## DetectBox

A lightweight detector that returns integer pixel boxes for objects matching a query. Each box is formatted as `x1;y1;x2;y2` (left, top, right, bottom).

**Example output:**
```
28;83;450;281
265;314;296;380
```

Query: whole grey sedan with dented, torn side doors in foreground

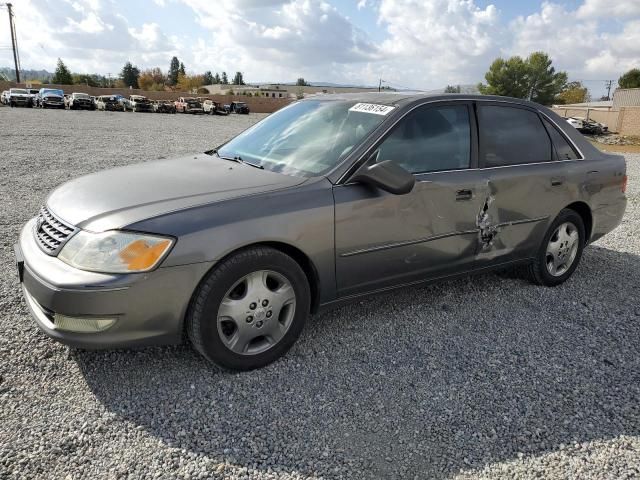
15;93;627;370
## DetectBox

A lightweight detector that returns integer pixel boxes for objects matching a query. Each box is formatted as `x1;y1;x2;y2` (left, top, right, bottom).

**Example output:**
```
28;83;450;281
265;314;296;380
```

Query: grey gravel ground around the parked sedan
0;108;640;479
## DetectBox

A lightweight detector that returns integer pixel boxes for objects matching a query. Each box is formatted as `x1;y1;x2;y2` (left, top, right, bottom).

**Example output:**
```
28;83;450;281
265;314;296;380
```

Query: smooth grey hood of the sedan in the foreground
47;154;305;232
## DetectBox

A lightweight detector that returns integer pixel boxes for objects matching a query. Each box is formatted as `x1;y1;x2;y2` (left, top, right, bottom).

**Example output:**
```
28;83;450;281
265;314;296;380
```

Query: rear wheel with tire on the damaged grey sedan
529;209;586;287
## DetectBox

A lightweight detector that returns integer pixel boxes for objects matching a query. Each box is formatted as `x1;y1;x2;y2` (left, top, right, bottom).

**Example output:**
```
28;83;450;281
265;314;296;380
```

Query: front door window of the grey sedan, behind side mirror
377;105;471;173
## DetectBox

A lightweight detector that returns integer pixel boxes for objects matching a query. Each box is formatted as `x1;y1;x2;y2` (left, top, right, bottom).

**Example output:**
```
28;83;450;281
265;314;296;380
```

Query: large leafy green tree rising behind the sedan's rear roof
478;52;567;105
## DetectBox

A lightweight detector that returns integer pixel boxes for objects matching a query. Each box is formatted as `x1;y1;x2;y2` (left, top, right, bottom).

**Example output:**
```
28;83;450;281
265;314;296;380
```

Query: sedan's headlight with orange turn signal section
58;230;174;273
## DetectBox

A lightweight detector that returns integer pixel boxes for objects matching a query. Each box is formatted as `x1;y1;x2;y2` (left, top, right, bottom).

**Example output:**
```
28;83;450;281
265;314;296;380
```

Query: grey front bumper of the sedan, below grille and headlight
16;219;213;349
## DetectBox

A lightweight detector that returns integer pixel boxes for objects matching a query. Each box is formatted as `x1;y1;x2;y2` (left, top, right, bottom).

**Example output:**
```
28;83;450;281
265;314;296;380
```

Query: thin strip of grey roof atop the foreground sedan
302;91;552;108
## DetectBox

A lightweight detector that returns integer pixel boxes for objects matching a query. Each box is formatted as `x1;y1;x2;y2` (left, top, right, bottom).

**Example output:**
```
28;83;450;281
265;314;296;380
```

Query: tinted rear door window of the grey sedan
478;105;552;167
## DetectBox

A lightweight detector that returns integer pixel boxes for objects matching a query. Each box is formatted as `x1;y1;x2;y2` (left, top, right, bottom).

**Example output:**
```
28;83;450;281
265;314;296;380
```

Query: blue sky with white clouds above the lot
0;0;640;96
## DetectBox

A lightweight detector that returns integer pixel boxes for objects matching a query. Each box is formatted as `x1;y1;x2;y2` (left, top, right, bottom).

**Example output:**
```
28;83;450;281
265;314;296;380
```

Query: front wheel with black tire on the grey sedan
186;247;311;370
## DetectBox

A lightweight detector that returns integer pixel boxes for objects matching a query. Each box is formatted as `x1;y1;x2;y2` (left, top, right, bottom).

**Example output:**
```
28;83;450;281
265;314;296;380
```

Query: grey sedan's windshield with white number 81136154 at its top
218;100;385;176
